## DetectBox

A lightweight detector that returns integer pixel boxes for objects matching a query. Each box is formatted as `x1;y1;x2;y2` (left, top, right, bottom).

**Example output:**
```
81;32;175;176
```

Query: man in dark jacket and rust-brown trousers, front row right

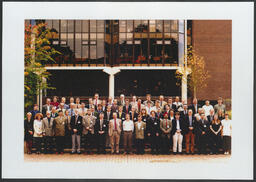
185;109;197;154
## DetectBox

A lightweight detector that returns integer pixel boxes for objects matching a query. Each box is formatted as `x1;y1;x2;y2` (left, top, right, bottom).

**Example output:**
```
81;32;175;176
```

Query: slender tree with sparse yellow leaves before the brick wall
176;46;210;98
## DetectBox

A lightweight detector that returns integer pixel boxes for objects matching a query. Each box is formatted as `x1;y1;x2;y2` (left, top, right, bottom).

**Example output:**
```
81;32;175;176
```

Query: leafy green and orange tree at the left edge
24;23;60;111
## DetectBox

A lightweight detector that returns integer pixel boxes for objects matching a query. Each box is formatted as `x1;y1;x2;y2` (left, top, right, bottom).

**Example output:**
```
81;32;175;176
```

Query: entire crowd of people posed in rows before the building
24;93;232;154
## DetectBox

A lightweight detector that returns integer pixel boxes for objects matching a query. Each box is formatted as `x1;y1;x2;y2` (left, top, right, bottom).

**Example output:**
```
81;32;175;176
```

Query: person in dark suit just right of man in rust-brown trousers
197;113;210;154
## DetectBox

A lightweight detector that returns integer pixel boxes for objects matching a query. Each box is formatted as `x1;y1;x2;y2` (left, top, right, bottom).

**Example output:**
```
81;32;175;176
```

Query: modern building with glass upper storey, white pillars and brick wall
26;20;231;106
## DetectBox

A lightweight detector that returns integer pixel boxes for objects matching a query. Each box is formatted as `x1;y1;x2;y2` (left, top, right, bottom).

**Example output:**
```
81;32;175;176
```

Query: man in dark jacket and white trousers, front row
171;112;185;155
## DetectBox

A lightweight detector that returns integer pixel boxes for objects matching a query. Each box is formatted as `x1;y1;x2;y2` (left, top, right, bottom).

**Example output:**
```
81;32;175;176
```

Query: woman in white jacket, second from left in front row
33;113;44;154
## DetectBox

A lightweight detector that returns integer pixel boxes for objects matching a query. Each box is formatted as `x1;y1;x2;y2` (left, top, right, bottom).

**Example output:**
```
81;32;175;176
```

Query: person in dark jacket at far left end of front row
24;112;33;154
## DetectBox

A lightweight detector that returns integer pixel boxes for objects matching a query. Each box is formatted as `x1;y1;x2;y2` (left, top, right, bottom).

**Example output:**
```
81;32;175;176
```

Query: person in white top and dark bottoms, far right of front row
221;113;232;155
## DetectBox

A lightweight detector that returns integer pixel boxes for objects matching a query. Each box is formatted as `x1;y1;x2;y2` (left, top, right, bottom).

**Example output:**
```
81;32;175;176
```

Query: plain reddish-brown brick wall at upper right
192;20;232;100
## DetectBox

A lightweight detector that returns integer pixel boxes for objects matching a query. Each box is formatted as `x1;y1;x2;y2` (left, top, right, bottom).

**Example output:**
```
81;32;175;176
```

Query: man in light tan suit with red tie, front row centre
108;112;122;154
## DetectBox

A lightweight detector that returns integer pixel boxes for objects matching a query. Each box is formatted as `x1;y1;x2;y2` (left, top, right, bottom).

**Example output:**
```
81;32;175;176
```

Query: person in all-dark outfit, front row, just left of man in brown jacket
147;111;161;154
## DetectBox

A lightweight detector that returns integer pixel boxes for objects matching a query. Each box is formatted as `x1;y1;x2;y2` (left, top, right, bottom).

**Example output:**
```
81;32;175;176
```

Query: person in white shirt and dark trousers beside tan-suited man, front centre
123;114;134;154
